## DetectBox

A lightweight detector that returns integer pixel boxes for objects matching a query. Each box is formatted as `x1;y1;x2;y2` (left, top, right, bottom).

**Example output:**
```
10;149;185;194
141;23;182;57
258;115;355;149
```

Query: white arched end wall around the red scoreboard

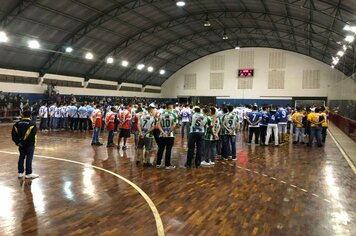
162;48;342;99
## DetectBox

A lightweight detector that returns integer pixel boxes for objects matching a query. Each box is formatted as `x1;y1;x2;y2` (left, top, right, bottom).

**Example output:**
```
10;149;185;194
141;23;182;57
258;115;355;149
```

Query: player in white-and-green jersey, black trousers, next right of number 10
186;107;210;168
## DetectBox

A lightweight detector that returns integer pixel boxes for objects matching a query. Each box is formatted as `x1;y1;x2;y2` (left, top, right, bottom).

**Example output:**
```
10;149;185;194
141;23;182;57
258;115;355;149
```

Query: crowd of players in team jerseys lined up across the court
21;97;328;169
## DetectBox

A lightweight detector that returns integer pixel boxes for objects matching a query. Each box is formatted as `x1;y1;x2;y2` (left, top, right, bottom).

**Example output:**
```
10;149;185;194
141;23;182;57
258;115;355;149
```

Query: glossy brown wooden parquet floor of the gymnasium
0;127;356;236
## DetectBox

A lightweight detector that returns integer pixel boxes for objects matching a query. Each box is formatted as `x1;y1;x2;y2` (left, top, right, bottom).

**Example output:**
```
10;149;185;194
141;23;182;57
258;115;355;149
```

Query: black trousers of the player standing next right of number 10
186;132;204;167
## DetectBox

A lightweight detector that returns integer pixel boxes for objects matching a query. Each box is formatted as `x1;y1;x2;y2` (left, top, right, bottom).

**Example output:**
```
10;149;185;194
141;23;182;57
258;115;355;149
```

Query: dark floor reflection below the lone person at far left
21;180;38;235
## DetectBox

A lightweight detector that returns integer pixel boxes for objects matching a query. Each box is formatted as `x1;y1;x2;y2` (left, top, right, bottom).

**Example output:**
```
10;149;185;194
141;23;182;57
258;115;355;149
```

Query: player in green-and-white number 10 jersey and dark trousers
156;103;178;170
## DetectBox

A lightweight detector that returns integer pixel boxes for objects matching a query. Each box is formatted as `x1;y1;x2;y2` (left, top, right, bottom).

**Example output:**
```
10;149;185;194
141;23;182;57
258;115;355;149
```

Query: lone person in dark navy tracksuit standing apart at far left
11;110;39;179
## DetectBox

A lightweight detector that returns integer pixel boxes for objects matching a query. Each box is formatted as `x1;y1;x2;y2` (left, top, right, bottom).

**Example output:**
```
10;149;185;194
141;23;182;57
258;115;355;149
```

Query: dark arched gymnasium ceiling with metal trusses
0;0;356;85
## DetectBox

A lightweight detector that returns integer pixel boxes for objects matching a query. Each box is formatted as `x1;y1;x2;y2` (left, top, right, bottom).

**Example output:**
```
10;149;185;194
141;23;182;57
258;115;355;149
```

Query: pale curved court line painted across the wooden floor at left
0;150;165;236
